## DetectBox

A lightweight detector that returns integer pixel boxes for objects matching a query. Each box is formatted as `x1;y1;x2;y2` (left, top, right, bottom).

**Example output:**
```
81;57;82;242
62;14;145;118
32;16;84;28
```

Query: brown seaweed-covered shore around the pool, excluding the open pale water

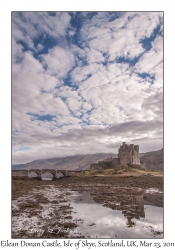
12;175;163;238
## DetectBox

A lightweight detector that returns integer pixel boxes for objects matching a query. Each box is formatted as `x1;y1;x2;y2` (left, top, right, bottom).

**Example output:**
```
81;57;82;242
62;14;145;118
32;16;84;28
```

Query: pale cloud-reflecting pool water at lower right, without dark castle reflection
71;191;163;239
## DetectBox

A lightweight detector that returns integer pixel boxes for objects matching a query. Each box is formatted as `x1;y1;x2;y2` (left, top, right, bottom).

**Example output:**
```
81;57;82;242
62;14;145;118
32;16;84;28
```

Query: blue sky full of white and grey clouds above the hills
12;12;163;164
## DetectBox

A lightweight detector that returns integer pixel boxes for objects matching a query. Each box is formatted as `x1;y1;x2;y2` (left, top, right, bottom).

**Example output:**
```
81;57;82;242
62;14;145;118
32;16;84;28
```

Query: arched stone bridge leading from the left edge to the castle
12;169;82;180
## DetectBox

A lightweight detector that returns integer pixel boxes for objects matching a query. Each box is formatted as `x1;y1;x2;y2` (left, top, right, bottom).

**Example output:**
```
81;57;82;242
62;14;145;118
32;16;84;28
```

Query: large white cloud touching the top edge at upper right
81;12;162;61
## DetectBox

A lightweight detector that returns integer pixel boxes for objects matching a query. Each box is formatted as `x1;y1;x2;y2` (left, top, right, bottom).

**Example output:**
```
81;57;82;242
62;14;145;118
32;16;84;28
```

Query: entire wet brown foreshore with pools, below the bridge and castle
12;176;163;238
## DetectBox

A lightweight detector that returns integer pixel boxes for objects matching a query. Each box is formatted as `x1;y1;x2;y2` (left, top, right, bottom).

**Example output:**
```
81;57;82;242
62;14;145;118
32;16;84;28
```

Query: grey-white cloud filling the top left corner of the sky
12;11;70;46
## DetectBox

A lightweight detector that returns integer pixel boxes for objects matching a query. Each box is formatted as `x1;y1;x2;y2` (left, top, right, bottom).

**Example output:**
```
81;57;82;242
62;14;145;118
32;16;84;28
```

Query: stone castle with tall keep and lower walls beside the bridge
90;142;142;170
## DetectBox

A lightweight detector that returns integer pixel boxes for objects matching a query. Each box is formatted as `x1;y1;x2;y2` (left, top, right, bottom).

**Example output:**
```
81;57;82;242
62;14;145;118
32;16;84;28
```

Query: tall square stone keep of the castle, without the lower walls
118;142;140;166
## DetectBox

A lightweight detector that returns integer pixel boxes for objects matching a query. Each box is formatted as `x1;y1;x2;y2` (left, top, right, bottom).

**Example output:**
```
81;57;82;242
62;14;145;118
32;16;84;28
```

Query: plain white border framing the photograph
0;0;175;249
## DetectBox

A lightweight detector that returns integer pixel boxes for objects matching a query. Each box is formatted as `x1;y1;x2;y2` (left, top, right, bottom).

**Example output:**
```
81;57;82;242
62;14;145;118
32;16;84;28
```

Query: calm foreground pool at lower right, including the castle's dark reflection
71;190;163;238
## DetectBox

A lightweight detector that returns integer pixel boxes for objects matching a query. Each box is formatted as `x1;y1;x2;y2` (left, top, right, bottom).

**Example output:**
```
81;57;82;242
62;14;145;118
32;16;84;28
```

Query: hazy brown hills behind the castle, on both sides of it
12;149;163;170
